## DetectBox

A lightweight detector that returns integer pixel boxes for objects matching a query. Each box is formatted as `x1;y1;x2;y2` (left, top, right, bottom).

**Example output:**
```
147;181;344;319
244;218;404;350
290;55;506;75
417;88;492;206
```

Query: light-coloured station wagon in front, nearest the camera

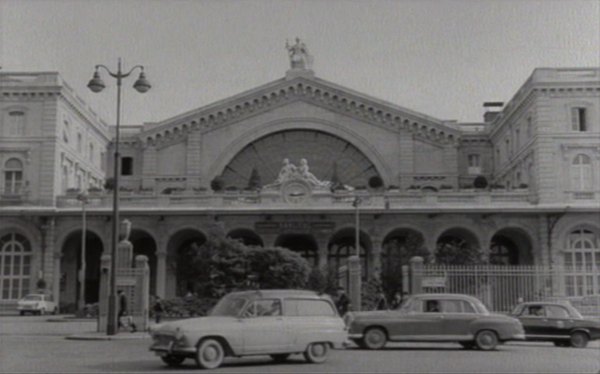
150;290;348;369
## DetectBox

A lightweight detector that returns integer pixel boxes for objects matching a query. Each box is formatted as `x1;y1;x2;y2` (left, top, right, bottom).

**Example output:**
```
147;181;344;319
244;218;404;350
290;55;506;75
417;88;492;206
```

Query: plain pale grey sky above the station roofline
0;0;600;124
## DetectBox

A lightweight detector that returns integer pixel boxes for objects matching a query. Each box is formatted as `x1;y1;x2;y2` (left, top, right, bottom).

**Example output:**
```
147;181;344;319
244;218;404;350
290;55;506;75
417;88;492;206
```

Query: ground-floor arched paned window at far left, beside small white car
0;232;31;300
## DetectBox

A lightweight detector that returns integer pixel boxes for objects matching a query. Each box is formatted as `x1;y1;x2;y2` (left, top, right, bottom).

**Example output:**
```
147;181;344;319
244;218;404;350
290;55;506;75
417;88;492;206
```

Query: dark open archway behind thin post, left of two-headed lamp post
59;230;104;312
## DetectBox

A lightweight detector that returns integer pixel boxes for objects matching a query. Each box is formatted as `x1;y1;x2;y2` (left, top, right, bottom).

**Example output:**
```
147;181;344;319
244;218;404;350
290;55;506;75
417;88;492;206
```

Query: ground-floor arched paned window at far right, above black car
564;229;600;296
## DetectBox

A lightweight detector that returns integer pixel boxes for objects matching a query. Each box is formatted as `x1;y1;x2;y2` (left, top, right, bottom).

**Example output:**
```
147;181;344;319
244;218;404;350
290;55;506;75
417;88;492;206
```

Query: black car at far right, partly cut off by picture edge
511;302;600;348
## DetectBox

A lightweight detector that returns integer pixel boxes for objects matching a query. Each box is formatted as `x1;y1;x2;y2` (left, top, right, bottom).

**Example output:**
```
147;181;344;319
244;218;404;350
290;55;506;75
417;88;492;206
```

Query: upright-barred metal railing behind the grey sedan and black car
422;265;600;317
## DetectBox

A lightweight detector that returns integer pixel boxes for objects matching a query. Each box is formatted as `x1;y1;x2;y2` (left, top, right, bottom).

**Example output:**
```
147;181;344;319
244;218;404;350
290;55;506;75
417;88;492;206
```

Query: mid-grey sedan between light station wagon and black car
349;294;525;350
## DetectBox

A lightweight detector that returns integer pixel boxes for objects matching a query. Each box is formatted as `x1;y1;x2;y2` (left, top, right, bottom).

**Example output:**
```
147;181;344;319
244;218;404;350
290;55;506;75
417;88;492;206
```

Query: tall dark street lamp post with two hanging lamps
88;58;152;335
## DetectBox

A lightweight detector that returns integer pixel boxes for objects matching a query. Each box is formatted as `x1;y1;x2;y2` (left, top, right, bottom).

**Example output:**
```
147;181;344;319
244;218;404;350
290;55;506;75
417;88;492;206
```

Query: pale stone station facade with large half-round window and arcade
0;60;600;307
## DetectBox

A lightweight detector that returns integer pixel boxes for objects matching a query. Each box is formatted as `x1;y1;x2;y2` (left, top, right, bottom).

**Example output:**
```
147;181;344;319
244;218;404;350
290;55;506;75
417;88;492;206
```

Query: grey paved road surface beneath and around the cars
0;317;600;373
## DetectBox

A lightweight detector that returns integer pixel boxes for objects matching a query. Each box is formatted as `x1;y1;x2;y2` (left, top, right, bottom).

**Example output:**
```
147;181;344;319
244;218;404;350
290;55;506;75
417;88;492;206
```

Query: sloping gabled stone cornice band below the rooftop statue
138;75;460;148
